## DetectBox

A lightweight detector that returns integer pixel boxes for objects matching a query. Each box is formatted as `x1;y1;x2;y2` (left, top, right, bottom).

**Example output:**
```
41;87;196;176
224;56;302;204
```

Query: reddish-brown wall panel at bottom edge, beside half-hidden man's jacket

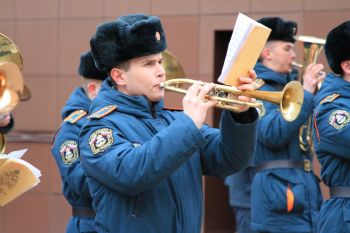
48;195;72;233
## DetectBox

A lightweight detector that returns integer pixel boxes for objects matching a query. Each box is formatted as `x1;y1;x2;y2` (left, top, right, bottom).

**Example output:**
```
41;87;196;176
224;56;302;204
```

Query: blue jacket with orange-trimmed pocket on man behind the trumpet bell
251;63;322;233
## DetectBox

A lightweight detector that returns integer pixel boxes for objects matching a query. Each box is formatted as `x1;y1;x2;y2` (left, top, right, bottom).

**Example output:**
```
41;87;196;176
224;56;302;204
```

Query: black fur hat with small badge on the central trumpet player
90;14;166;72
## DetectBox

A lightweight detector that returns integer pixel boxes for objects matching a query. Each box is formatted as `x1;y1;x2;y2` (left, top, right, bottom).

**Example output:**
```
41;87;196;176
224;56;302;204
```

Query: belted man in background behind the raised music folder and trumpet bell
251;17;325;233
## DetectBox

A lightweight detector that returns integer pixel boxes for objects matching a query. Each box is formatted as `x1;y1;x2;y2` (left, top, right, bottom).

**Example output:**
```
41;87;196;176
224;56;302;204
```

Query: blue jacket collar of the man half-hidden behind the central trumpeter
61;87;91;119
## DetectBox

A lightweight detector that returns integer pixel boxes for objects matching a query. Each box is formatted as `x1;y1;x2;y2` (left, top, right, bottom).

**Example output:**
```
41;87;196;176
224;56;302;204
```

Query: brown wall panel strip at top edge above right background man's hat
251;0;304;14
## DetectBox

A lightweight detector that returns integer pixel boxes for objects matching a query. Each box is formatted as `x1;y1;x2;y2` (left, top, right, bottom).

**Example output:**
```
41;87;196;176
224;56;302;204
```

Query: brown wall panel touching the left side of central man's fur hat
58;19;103;75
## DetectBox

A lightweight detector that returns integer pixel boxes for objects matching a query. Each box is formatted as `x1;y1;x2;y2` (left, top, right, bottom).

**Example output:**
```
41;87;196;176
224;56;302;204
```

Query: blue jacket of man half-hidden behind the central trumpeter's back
52;88;96;233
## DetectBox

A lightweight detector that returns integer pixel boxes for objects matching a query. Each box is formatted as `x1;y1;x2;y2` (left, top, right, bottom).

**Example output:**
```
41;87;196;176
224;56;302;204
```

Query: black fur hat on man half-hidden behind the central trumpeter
78;51;108;80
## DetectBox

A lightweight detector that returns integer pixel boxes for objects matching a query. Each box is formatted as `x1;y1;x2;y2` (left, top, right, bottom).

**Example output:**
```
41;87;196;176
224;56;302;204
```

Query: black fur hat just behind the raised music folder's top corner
258;17;298;43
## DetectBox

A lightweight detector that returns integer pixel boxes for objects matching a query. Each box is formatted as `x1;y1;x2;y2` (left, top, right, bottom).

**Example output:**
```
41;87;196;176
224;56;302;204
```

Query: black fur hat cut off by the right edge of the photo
324;20;350;74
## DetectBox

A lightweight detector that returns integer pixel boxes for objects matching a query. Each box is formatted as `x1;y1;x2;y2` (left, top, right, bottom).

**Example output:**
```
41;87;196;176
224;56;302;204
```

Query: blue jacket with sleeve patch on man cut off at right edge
313;73;350;233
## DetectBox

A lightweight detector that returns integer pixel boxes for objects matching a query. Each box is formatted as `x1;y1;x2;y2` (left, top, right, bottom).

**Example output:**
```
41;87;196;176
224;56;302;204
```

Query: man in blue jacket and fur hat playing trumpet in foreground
79;14;258;233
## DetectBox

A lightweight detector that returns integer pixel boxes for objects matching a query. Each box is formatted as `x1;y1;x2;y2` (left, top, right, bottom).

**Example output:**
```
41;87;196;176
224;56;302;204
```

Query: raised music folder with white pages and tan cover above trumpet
218;13;271;86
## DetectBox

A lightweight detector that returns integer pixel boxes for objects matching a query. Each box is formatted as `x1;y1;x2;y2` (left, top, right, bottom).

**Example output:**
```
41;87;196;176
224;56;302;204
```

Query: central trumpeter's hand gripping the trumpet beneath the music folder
228;70;256;112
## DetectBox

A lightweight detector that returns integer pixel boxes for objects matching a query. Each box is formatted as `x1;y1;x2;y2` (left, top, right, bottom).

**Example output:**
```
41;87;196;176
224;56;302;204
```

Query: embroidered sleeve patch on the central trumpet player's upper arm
89;128;114;155
